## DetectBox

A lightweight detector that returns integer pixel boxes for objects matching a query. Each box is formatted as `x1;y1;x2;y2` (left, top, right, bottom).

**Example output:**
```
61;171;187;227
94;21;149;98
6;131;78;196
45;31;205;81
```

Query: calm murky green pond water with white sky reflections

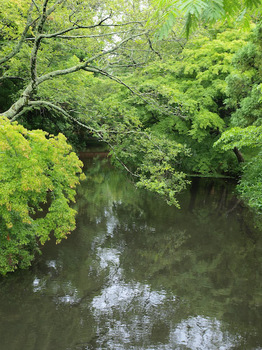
0;161;262;350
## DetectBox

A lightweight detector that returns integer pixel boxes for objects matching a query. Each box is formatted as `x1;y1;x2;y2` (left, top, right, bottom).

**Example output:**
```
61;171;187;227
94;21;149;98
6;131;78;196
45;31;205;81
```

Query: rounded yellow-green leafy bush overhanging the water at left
0;117;84;274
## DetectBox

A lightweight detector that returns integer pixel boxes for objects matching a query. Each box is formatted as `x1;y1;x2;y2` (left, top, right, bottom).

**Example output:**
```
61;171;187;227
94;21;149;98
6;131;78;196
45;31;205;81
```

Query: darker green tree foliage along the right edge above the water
214;24;262;212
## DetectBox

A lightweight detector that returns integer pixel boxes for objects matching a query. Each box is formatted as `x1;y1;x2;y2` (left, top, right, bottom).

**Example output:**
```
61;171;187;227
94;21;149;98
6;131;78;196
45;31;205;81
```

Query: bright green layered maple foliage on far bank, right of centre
105;29;247;174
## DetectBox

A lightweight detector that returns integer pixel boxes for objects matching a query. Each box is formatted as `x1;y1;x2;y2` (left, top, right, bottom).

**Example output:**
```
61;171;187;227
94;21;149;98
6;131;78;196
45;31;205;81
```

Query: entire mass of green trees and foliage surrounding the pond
0;0;262;275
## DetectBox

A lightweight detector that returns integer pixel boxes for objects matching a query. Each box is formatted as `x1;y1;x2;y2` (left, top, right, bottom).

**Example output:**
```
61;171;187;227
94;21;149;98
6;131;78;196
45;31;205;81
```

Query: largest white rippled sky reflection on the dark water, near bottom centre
91;248;166;349
